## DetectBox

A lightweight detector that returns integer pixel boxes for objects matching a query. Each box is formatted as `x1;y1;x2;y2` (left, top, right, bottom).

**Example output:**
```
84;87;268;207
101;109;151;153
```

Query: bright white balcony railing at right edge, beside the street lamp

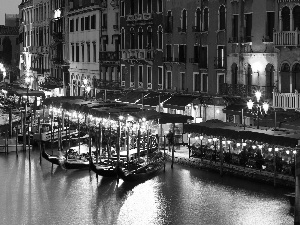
273;92;300;109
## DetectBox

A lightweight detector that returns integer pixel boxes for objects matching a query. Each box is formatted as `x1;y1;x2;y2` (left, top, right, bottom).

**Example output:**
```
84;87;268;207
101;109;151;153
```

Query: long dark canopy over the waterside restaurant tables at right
183;121;300;147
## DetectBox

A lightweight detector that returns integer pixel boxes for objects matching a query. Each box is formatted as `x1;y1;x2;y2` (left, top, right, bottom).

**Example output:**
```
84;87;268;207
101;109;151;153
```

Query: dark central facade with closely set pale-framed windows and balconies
120;0;164;91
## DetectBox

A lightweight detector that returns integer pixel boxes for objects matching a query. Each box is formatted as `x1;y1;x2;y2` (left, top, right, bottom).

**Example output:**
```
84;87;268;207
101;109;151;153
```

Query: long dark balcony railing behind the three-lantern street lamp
219;83;275;100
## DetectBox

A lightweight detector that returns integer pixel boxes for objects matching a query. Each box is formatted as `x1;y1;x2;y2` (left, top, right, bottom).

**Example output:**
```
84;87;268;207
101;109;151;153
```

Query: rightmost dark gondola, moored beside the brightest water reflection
117;153;164;181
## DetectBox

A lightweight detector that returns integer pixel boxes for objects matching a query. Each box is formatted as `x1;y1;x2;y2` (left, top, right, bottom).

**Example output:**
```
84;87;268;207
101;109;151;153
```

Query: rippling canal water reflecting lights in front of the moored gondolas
0;150;293;225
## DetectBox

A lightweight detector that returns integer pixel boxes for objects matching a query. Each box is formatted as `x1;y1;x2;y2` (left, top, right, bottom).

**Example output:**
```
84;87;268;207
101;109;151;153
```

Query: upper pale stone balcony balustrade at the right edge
273;30;300;47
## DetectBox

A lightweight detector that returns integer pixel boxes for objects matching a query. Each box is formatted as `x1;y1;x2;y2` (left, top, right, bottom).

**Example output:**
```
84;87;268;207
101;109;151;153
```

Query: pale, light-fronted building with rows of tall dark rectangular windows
67;0;112;96
